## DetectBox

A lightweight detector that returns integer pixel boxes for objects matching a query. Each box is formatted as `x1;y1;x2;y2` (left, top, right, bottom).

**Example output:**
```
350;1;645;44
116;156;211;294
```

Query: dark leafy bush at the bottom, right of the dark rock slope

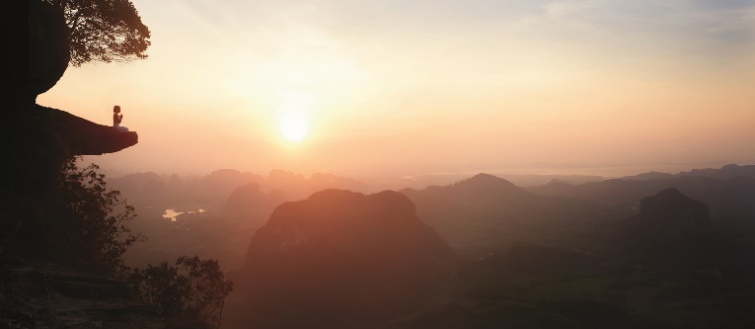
127;256;233;327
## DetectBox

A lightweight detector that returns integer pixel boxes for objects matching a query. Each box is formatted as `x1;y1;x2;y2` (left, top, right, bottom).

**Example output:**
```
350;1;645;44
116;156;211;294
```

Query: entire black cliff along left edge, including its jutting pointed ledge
0;0;143;328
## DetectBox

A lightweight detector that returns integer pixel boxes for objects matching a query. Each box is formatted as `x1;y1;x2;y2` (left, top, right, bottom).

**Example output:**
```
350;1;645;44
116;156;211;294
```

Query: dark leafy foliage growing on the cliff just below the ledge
51;157;145;273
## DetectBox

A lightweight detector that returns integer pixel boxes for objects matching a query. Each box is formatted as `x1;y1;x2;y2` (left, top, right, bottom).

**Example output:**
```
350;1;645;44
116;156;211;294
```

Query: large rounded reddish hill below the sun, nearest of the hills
234;190;454;328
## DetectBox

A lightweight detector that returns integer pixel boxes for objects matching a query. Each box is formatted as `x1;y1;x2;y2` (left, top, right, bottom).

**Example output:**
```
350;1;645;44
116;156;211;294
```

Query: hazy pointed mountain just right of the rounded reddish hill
399;174;609;255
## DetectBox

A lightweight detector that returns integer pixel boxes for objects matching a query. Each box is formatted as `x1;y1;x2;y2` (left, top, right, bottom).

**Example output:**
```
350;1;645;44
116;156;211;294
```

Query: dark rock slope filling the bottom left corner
0;259;174;329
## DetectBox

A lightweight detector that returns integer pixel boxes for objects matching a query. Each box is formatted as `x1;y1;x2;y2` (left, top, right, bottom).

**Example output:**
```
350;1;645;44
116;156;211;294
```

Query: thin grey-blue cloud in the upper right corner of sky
522;0;755;64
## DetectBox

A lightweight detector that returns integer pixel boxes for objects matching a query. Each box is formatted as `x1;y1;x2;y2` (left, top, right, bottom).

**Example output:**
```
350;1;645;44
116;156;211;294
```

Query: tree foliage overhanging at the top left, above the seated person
44;0;150;66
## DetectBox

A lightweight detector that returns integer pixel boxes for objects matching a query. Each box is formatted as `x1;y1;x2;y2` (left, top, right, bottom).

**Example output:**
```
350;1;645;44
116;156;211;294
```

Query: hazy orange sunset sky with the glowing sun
38;0;755;179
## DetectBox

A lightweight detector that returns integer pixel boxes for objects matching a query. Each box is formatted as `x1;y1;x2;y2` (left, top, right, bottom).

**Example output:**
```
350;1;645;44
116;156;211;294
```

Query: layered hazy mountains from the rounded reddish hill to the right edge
216;166;755;329
